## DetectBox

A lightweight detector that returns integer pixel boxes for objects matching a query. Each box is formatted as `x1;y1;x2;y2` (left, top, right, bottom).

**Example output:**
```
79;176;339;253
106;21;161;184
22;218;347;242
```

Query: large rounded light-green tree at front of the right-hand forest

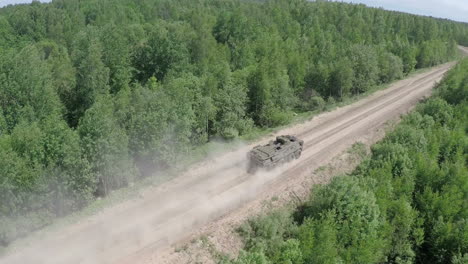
304;177;382;263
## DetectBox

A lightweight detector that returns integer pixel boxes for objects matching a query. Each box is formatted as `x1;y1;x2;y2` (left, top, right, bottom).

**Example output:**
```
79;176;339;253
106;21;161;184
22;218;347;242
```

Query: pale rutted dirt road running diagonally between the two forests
0;63;453;264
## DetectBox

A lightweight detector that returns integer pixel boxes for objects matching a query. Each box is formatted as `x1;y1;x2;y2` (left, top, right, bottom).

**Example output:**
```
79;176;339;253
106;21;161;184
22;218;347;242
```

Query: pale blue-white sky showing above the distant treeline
0;0;468;22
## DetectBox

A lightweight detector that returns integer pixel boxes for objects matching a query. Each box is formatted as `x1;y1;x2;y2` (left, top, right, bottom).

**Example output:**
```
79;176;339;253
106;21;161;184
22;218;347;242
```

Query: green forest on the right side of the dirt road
229;59;468;264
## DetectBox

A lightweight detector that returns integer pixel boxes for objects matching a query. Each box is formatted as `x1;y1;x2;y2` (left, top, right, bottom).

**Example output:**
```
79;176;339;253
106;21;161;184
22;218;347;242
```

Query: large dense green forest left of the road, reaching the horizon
0;0;468;246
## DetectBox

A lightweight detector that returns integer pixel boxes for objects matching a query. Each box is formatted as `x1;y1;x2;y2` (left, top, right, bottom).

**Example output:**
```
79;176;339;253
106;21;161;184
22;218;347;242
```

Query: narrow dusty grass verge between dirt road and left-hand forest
0;62;450;254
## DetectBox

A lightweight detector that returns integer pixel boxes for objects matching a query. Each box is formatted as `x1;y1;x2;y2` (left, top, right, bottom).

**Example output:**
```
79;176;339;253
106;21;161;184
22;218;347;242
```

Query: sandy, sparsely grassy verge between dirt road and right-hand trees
155;131;378;264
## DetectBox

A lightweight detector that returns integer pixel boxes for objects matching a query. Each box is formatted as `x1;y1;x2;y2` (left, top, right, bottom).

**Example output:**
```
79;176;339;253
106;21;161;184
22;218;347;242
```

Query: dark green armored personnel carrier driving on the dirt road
247;135;304;173
